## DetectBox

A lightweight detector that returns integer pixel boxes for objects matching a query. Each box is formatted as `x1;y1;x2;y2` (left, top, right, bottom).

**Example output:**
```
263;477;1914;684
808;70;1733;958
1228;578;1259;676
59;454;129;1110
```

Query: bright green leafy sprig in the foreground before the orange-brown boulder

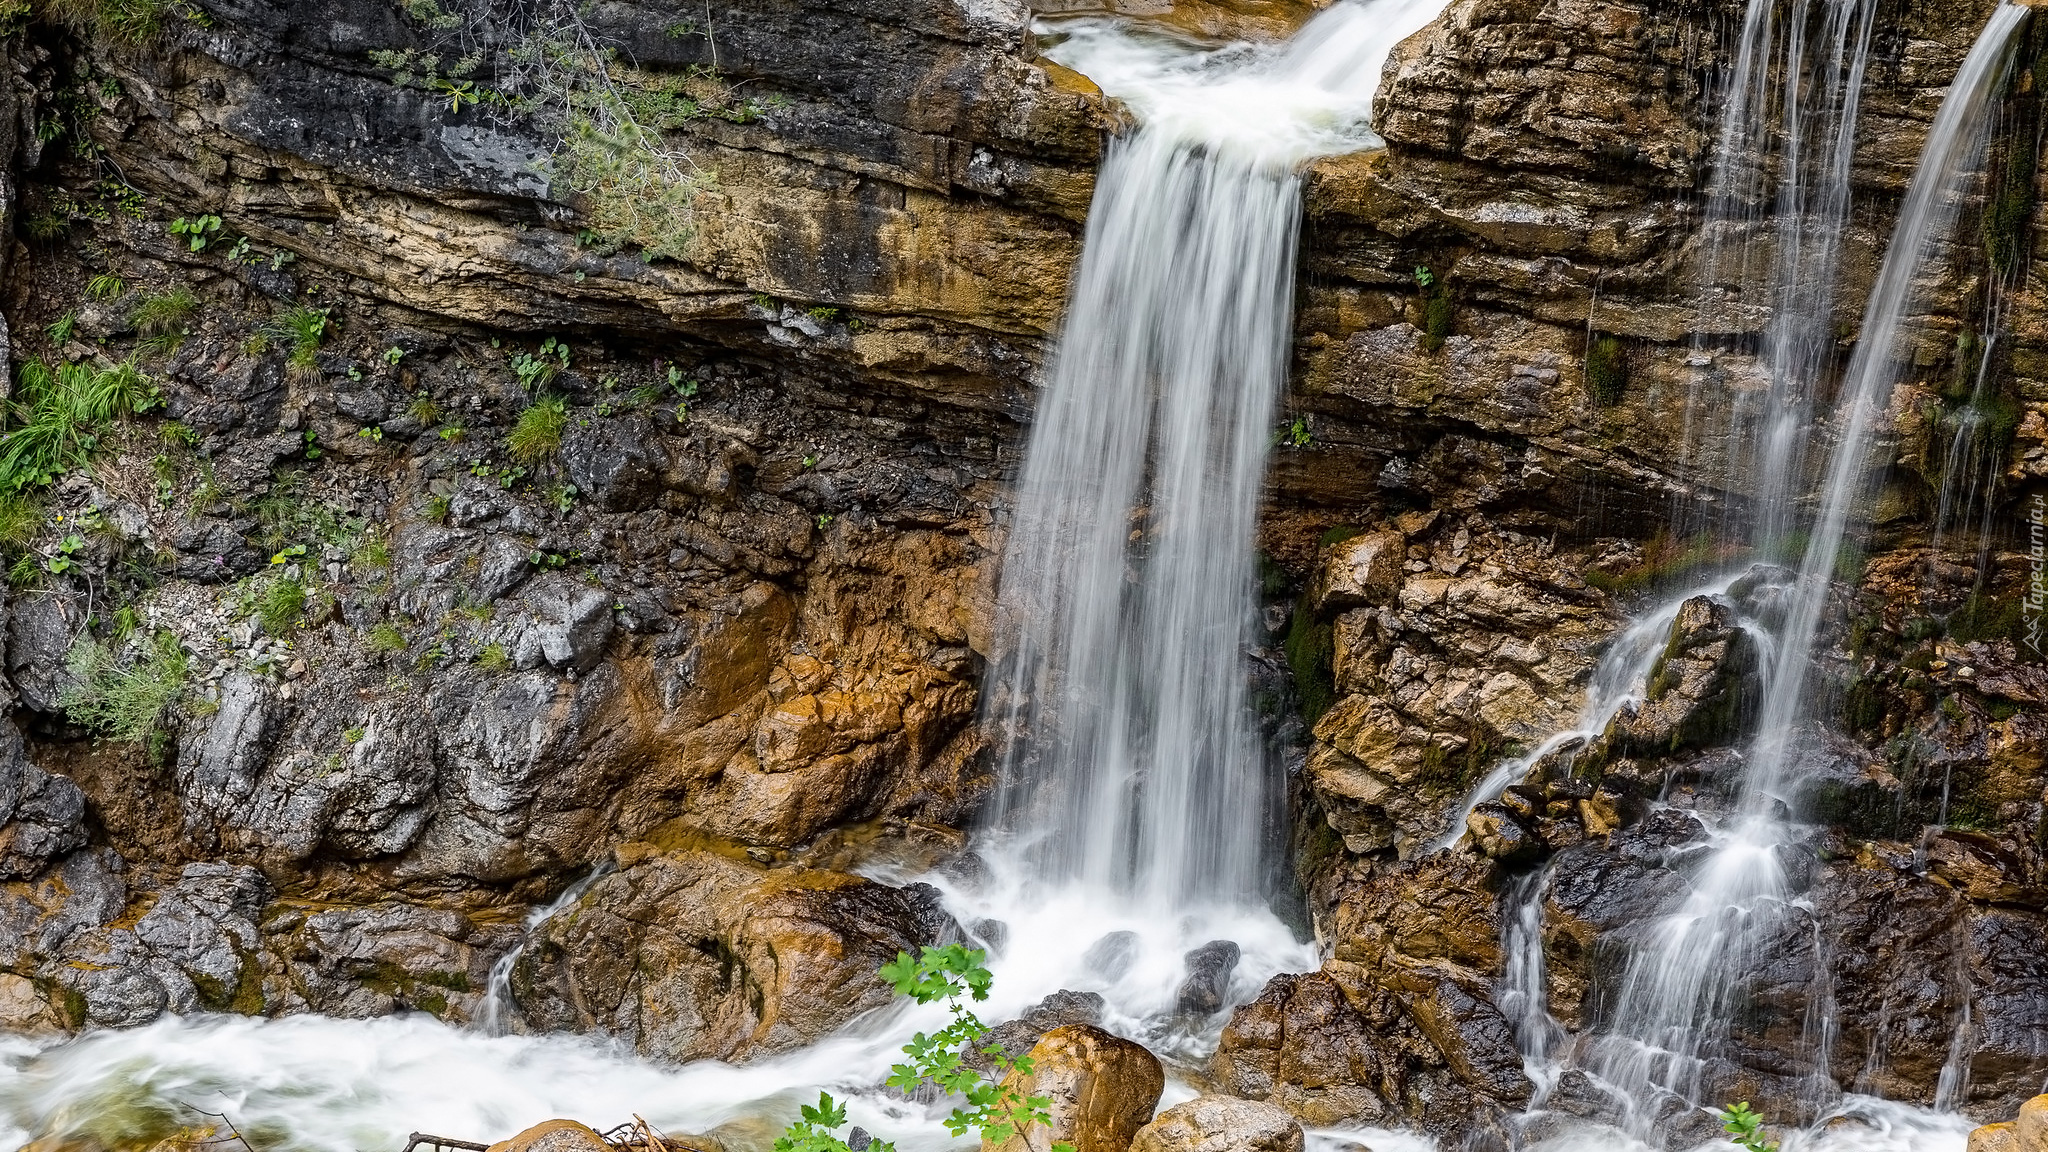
774;945;1073;1152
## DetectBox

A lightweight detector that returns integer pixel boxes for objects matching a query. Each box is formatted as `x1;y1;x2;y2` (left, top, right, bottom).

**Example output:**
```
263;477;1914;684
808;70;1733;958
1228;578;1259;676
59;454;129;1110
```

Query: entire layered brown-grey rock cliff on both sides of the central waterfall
0;0;2048;1127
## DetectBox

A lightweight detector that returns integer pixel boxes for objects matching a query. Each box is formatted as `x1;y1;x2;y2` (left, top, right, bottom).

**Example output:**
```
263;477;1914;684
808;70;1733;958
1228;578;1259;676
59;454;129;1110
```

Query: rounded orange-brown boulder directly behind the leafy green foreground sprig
981;1025;1165;1152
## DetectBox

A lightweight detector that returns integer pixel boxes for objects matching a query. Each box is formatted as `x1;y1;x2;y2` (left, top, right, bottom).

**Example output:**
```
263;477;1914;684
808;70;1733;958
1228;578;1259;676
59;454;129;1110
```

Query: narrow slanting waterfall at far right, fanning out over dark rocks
1482;4;2028;1148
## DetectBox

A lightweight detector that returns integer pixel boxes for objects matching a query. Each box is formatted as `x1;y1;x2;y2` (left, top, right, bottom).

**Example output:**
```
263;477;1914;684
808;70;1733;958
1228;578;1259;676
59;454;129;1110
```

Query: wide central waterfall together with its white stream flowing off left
0;0;1444;1152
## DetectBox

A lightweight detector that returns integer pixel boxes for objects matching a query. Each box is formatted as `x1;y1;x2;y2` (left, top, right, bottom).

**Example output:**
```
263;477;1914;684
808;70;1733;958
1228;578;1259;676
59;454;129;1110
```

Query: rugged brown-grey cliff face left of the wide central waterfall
4;2;1110;1041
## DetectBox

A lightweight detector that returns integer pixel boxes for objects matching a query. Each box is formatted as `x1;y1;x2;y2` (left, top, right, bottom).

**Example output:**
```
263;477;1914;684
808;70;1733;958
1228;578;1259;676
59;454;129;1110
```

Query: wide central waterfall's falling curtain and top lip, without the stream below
991;0;1442;906
